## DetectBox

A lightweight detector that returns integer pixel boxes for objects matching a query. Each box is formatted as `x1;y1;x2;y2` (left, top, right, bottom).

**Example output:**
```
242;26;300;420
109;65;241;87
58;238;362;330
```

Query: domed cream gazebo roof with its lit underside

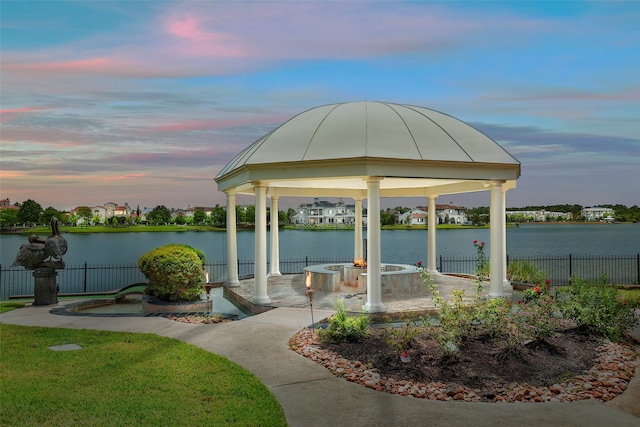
215;101;520;197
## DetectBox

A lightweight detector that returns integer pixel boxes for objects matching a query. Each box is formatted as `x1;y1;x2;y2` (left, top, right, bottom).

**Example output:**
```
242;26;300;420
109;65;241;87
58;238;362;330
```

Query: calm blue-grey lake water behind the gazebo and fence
0;224;640;268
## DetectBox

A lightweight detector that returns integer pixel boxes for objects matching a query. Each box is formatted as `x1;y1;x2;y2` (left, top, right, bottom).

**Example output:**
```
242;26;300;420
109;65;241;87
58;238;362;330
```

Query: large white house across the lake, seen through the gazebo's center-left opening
291;198;367;225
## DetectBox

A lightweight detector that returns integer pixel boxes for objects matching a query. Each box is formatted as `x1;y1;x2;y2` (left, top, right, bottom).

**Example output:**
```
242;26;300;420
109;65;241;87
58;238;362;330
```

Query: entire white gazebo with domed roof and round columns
215;101;520;313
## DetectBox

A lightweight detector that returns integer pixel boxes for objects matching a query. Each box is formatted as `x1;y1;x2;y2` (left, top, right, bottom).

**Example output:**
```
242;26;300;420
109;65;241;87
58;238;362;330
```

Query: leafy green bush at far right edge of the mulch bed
560;277;638;341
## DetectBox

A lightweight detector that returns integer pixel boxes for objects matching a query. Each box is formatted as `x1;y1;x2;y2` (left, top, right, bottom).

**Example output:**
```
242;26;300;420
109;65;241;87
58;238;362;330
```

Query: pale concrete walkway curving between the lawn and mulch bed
0;278;640;427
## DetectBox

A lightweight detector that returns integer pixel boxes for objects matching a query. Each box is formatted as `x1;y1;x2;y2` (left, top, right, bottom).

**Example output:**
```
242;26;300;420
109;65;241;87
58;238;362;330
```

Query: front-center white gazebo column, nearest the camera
364;177;387;313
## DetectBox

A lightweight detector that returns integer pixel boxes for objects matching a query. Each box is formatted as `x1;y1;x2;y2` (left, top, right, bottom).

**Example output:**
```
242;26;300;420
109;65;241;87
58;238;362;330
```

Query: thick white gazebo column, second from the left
252;183;271;304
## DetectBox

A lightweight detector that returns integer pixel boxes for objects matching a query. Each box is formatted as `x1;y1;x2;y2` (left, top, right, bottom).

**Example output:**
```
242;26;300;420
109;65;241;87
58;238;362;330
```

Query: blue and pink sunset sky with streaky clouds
0;0;640;210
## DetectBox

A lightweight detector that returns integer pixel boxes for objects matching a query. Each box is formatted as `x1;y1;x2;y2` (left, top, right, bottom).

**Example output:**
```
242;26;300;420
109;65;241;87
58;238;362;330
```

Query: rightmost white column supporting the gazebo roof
489;182;504;298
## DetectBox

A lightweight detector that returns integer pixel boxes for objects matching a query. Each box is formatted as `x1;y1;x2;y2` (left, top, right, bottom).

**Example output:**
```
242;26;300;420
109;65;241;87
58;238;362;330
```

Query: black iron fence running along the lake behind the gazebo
0;254;640;301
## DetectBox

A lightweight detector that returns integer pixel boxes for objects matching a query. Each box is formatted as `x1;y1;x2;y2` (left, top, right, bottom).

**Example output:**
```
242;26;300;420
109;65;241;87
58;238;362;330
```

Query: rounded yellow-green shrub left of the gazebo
138;244;205;301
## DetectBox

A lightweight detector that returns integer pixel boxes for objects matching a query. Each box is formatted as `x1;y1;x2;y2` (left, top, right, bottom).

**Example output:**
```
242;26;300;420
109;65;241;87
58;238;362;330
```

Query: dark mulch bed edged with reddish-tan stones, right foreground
290;327;637;402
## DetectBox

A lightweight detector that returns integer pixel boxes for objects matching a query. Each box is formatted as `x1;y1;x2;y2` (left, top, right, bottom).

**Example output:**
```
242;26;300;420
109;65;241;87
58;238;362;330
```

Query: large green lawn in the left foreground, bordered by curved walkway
0;324;286;426
